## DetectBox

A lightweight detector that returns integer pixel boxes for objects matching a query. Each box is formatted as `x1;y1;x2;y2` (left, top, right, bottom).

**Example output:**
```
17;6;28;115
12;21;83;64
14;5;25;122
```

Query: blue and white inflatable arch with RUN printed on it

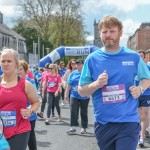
39;46;99;67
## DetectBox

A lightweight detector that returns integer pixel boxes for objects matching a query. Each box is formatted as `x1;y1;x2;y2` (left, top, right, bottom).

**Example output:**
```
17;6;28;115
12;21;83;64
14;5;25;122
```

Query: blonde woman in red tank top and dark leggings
0;49;40;150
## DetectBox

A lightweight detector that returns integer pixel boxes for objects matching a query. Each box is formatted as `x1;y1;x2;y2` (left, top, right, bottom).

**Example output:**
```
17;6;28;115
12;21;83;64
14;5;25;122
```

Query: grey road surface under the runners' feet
31;96;150;150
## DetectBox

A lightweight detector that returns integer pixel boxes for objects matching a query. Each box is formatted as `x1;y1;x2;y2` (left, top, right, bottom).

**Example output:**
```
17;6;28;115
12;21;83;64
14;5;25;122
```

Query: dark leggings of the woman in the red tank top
7;132;30;150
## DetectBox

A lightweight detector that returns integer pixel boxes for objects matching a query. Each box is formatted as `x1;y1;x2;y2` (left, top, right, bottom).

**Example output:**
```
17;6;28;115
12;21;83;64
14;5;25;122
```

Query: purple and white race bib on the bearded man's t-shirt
102;84;126;104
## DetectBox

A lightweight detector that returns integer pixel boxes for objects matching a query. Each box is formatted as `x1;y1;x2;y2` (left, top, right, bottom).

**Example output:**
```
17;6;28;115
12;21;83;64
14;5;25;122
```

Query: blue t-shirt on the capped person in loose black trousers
67;70;88;100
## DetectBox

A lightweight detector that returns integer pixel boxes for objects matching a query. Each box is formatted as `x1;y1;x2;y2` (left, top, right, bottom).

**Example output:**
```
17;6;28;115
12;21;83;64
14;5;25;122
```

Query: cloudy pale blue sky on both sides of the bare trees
0;0;150;46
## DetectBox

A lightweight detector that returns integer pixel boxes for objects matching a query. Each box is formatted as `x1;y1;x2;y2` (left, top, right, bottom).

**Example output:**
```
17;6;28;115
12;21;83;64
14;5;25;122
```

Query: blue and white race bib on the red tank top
0;111;16;127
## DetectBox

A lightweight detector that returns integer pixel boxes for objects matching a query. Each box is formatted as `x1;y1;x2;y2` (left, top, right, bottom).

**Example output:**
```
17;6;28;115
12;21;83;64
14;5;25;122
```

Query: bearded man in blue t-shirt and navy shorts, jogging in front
78;16;150;150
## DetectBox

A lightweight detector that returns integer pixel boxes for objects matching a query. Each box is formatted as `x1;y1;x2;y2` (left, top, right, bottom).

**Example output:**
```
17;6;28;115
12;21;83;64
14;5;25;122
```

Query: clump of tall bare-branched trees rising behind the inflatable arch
18;0;87;48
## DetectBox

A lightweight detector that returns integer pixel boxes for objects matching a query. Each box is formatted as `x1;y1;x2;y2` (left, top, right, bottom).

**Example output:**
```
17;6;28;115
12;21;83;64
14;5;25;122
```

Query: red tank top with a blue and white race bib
0;78;31;139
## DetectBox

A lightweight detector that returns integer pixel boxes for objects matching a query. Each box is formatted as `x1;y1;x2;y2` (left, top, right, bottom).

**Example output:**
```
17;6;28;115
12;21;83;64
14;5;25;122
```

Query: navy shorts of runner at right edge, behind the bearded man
138;95;150;107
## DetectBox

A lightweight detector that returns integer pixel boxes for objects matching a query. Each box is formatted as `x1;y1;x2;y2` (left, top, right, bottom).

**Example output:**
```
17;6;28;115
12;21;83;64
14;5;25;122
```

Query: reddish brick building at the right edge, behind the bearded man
127;23;150;62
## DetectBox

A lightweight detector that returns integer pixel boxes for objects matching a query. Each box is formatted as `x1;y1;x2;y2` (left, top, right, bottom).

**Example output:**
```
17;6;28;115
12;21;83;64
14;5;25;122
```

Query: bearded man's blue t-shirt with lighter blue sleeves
79;47;150;124
